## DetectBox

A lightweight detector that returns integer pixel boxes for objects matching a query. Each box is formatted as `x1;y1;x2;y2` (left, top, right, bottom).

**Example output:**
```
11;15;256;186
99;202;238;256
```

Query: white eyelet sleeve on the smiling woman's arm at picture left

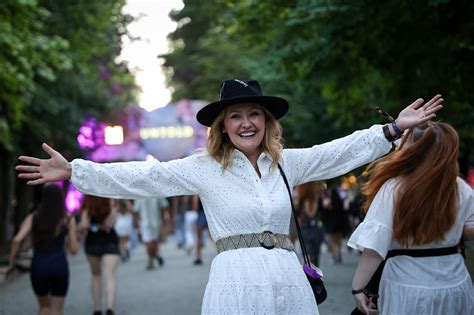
71;156;200;199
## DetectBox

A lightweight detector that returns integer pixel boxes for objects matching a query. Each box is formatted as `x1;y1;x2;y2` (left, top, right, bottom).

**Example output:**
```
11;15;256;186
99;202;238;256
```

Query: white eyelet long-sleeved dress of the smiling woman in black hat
72;125;390;315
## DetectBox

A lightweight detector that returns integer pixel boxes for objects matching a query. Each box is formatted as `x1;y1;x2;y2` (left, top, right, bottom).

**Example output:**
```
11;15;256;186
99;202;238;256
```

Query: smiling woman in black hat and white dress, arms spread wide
16;80;443;315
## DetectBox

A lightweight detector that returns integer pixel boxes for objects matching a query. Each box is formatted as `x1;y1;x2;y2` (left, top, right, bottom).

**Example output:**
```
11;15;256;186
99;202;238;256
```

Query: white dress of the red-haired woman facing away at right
348;179;474;315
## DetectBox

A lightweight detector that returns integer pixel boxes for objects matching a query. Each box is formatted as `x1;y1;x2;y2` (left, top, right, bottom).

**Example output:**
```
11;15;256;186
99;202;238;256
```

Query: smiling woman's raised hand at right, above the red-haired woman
396;94;444;131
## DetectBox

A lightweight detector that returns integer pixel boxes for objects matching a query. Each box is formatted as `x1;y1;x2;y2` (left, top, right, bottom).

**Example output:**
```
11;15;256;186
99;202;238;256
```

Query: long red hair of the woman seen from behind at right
362;122;459;246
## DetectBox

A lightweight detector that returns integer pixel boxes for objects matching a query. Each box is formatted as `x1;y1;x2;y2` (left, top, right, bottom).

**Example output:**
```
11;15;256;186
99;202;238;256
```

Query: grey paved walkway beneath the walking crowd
0;238;358;315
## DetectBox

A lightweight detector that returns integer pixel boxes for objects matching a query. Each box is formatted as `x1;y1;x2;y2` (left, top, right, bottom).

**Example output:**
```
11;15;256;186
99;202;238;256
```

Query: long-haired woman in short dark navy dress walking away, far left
7;184;79;315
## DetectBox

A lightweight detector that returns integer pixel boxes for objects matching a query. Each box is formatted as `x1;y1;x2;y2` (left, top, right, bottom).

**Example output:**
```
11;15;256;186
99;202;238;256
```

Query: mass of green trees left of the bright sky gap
0;0;137;241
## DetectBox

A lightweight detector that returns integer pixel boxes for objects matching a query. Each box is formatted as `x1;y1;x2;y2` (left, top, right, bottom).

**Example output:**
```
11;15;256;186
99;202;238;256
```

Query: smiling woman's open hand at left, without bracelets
15;143;71;185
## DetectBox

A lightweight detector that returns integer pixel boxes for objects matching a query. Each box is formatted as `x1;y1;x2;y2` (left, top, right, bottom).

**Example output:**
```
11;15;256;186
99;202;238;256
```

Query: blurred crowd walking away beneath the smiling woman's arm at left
6;190;205;315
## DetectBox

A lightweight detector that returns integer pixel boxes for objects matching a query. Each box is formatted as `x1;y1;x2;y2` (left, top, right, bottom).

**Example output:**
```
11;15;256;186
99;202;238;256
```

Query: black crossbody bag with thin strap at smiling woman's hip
278;164;328;304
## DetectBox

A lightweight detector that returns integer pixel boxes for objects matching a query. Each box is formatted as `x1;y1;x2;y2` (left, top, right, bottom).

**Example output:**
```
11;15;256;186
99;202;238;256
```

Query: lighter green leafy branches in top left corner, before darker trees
0;0;71;151
